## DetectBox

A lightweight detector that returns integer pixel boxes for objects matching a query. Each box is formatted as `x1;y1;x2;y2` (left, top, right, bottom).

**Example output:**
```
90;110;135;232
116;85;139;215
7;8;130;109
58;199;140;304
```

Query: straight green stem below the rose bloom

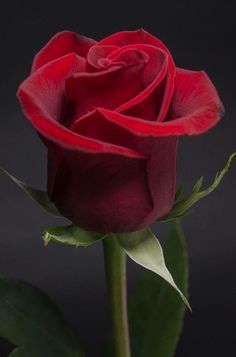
103;235;131;357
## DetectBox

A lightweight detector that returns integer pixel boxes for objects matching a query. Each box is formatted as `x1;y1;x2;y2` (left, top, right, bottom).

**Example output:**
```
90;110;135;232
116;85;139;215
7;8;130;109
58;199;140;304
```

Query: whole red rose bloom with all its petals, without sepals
18;30;223;233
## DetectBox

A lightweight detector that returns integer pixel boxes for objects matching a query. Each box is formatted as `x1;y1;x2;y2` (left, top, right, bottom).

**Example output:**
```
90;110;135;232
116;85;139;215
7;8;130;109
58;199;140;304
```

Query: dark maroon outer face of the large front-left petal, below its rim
48;150;152;233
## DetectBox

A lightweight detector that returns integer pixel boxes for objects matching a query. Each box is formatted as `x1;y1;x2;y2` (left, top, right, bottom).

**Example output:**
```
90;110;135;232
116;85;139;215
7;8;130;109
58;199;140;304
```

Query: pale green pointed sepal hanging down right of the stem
115;228;191;310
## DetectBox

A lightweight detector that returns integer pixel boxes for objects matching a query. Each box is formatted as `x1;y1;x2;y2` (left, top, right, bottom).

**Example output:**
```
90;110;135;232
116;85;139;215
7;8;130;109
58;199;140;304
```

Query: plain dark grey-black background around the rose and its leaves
0;0;236;357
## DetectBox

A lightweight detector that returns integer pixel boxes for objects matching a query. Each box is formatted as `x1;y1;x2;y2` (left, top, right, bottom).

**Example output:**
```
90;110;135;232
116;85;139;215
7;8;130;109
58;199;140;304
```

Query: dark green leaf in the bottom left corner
0;277;84;357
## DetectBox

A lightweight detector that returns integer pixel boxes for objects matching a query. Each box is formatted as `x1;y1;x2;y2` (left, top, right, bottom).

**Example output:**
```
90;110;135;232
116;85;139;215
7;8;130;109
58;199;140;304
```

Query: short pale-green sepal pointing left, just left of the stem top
42;224;105;247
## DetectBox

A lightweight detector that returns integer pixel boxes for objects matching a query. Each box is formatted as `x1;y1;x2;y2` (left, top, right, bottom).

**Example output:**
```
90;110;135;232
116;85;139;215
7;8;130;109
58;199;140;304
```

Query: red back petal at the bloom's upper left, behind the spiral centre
32;31;97;72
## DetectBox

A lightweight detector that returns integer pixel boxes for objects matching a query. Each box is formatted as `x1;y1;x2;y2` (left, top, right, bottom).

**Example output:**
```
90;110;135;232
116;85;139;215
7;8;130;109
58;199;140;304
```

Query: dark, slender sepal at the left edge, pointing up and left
0;167;61;216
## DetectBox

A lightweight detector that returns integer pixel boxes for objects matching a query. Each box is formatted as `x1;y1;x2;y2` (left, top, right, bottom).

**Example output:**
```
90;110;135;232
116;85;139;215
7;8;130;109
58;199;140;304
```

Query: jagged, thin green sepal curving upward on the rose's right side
161;153;236;222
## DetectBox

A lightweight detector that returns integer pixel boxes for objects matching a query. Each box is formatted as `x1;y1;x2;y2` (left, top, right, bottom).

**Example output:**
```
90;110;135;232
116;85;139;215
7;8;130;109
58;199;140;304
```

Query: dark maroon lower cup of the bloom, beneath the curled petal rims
48;131;177;233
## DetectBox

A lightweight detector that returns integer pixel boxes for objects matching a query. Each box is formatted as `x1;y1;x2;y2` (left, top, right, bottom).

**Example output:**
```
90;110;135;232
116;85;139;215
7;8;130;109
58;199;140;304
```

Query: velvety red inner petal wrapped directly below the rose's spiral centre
66;49;148;122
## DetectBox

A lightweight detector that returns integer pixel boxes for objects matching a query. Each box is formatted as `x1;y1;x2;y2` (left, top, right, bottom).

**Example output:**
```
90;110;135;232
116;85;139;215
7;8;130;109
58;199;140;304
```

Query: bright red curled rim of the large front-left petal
17;54;146;159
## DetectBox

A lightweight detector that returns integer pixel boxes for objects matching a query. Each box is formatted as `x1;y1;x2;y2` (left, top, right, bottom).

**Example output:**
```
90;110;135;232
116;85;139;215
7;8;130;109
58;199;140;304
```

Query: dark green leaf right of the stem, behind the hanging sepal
129;222;188;357
